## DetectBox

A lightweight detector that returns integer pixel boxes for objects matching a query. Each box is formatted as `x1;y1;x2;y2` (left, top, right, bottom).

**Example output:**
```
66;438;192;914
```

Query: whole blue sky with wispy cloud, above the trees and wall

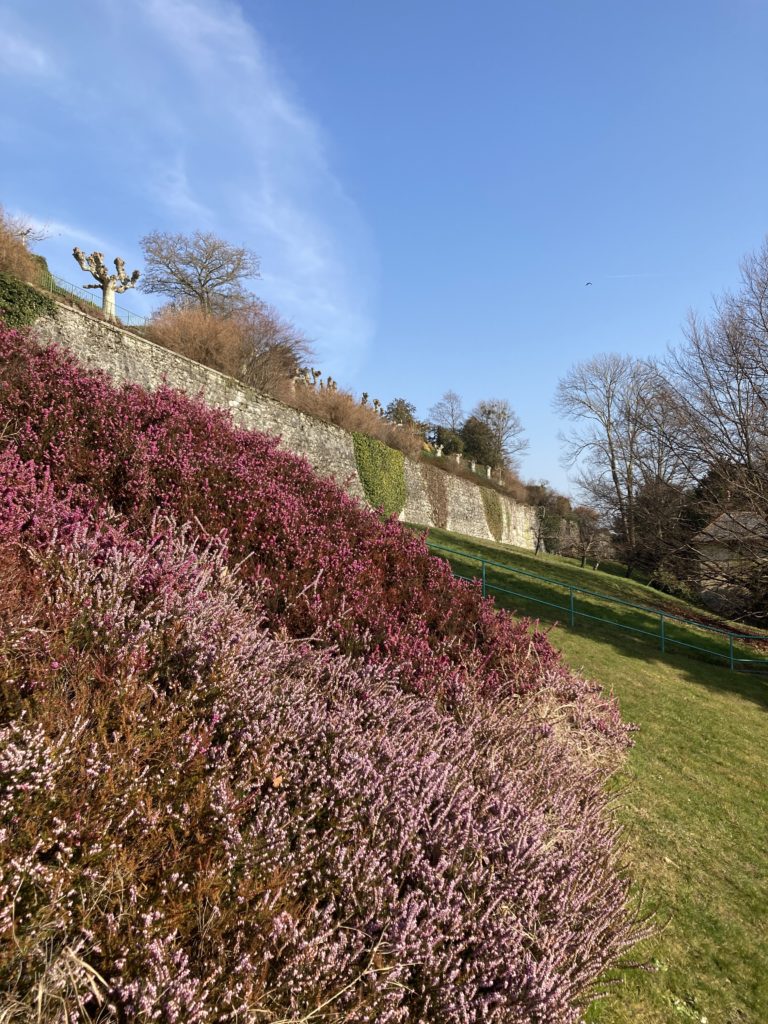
0;0;768;490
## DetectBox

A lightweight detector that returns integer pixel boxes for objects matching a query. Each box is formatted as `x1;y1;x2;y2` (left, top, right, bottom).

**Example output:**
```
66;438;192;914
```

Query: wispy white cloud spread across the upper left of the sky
0;0;376;380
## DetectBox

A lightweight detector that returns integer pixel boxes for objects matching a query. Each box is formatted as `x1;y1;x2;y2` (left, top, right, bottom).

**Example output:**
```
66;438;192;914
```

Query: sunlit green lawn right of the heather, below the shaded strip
421;531;768;1024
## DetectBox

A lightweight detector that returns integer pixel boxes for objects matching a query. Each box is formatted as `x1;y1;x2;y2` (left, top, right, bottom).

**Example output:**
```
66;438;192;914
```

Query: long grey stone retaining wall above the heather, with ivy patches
35;303;535;550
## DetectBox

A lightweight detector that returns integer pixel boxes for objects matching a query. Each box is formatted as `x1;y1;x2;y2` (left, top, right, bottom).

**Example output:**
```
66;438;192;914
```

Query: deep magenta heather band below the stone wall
0;330;627;757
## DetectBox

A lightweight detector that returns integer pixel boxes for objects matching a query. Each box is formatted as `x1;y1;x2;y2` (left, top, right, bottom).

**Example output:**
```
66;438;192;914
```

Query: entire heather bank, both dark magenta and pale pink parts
0;330;642;1024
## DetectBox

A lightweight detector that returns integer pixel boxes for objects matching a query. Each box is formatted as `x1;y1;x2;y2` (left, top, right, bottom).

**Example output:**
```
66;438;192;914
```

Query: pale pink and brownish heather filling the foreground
0;491;651;1024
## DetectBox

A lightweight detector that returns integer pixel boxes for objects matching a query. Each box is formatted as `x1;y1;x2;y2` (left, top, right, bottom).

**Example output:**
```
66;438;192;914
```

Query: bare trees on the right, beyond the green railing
555;240;768;618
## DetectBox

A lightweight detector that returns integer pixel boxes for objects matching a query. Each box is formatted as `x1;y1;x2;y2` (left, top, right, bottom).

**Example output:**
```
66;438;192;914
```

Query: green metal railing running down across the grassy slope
427;542;768;673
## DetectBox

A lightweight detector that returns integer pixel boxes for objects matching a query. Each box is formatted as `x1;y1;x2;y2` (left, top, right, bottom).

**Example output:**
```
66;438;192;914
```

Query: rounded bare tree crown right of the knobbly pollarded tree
141;231;259;314
